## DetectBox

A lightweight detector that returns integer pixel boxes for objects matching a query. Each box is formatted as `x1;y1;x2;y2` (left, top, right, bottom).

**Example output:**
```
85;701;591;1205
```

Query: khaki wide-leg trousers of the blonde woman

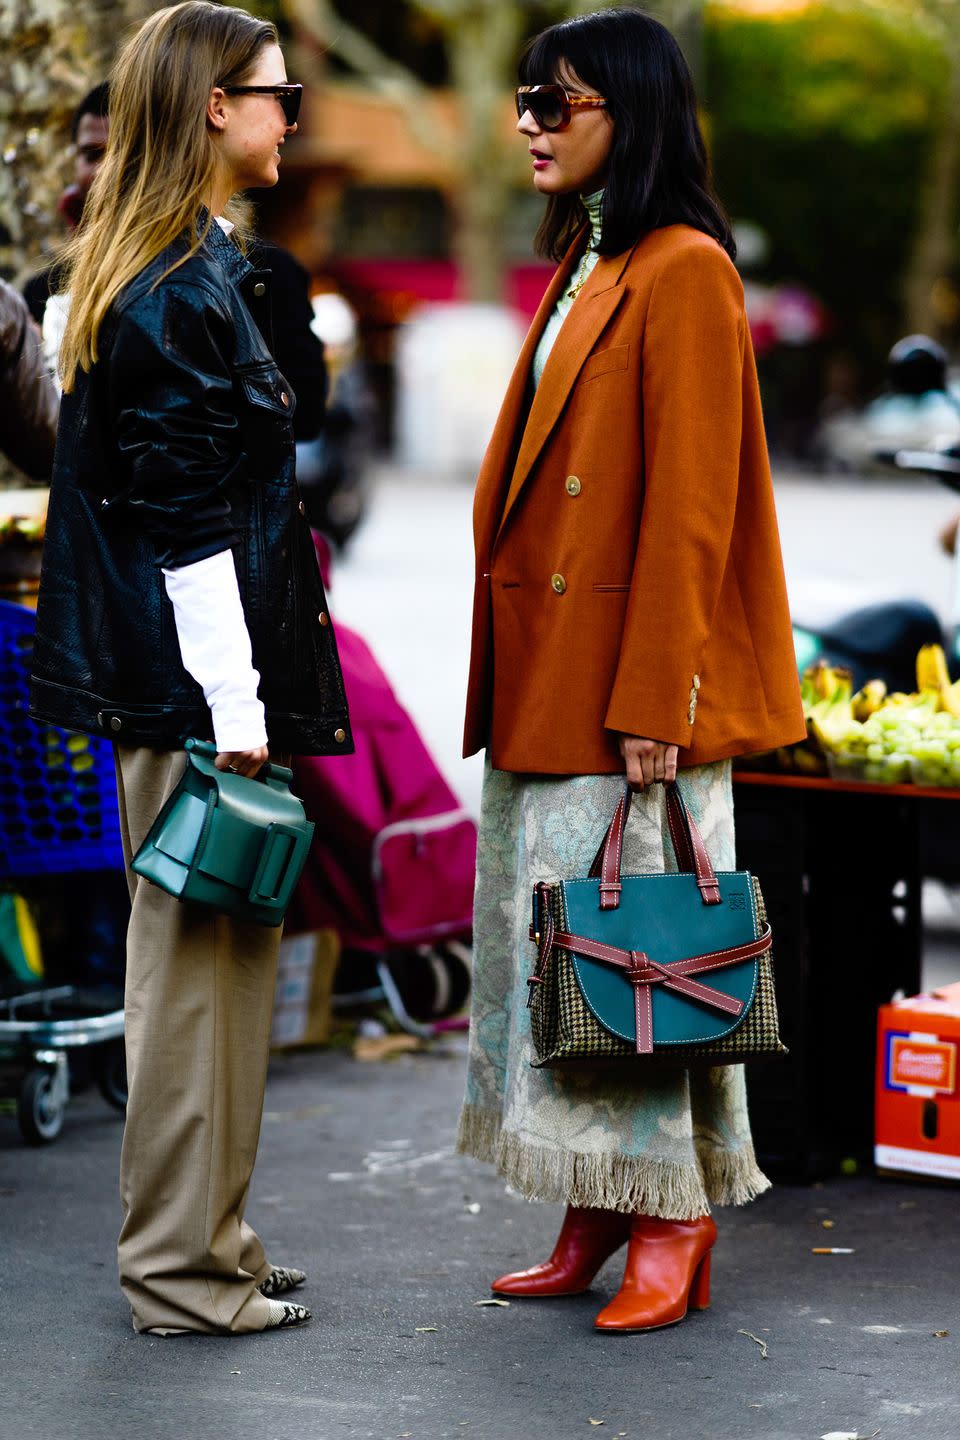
117;746;281;1333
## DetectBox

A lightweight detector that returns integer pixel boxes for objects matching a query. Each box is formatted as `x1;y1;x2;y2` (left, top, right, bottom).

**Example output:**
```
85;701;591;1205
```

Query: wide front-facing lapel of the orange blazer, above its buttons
498;251;632;534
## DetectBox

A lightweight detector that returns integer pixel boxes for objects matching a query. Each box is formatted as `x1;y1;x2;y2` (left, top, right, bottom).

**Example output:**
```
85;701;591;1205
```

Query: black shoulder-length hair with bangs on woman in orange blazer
520;9;737;261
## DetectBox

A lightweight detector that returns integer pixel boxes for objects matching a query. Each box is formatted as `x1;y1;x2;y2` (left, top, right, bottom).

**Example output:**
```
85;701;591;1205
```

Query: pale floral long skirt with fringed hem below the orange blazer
458;760;770;1220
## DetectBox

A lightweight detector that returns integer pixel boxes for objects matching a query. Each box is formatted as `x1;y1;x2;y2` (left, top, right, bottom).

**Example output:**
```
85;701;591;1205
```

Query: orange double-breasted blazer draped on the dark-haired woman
463;225;805;775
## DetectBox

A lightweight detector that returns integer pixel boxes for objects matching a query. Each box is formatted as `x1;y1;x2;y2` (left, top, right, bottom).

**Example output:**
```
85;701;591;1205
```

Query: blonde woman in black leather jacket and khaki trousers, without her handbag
33;0;351;1335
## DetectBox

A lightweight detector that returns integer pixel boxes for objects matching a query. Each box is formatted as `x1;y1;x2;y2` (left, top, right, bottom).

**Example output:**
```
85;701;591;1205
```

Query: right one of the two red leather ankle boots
594;1215;717;1331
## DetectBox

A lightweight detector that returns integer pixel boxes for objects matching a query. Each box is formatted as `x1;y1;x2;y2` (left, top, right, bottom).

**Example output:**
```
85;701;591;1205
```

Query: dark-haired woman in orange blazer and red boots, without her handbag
459;9;803;1331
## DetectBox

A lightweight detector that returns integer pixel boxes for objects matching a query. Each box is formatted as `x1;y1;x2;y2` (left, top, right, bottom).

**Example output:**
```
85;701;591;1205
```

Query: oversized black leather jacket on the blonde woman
30;225;353;755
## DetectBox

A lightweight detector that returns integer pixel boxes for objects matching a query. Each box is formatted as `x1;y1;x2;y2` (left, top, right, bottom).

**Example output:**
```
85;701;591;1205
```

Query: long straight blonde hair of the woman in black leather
60;0;276;390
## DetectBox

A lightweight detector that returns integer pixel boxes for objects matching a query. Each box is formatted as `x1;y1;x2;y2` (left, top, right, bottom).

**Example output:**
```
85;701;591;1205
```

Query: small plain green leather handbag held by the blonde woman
131;740;314;924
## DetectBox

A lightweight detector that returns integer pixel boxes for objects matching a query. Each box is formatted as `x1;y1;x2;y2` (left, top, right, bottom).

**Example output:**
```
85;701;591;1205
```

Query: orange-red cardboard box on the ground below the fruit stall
874;984;960;1179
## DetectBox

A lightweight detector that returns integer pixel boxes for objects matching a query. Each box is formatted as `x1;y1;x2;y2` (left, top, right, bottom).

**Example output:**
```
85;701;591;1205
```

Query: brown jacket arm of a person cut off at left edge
0;279;59;480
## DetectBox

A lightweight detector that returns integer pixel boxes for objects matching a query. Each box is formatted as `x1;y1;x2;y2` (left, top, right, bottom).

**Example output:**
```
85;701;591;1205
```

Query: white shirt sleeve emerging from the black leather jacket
163;550;266;752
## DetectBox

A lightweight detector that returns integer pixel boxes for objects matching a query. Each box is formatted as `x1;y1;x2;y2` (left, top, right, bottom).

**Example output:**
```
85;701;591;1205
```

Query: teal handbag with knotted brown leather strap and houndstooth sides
528;783;786;1066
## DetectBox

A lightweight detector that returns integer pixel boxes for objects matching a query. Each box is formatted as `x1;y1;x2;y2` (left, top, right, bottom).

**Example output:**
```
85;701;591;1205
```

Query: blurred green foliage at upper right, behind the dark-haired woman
704;4;948;360
